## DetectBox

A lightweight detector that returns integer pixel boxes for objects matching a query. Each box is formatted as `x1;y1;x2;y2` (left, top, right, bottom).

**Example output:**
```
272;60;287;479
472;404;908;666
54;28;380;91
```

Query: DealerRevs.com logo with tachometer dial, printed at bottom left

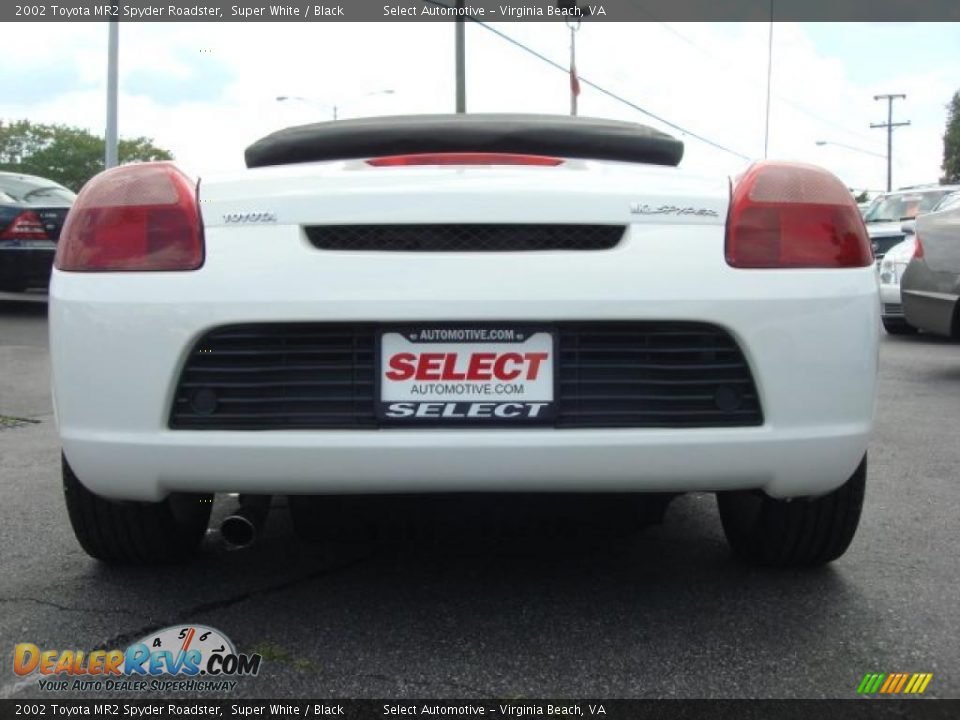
13;625;263;692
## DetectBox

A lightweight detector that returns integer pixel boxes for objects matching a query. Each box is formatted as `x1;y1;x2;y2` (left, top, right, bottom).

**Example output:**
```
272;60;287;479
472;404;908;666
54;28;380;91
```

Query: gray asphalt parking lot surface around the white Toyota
0;295;960;699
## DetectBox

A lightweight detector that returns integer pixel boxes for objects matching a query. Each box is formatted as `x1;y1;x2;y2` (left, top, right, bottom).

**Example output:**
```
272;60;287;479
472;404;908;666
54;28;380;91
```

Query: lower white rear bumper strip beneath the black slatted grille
63;423;868;499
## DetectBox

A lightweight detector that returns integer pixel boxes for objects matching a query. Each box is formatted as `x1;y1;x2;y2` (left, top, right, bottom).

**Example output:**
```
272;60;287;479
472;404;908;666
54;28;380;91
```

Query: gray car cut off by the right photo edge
900;191;960;337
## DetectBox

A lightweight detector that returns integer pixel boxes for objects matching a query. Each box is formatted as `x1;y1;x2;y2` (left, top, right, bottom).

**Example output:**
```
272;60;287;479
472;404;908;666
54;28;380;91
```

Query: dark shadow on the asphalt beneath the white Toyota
79;495;864;647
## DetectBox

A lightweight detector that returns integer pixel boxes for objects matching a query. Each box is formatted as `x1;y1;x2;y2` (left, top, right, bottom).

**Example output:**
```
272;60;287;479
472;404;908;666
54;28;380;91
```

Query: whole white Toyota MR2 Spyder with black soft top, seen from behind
50;115;879;566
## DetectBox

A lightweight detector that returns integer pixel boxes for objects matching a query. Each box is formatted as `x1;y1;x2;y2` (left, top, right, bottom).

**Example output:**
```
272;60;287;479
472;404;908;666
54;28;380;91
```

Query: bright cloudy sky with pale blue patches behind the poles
0;22;960;189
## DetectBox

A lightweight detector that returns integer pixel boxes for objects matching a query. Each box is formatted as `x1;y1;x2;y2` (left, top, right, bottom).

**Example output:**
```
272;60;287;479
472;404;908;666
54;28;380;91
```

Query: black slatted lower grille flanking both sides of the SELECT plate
170;321;763;430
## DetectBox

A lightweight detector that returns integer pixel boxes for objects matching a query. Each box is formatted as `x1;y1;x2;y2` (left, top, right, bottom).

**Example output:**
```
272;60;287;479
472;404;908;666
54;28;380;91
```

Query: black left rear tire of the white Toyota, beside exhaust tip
62;458;213;565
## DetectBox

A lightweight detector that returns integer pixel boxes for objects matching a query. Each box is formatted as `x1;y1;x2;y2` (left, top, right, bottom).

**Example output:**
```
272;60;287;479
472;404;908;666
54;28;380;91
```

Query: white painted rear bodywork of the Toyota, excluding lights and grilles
50;161;879;500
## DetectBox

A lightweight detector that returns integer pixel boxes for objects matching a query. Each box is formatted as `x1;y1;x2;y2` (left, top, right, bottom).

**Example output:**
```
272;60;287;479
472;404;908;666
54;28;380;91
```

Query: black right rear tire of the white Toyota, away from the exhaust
717;456;867;567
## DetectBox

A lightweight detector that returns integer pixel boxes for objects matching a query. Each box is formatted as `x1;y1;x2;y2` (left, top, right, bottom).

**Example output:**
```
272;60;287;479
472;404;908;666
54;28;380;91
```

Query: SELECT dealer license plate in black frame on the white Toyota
378;326;556;425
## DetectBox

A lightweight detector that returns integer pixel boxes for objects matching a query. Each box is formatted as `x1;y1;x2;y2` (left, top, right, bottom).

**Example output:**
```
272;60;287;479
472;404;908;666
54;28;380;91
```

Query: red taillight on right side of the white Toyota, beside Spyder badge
726;161;873;268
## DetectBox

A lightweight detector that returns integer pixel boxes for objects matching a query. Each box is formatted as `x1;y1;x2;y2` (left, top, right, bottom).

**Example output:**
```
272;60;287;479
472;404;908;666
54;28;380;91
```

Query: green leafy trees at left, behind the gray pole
0;120;173;191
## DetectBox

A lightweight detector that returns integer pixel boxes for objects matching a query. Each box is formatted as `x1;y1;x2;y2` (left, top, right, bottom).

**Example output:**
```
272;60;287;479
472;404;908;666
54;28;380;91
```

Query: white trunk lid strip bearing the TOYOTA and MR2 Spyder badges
200;159;730;232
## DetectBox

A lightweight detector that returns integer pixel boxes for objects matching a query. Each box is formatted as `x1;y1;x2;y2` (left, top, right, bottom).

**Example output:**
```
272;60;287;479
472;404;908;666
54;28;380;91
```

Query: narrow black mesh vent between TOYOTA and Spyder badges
305;224;626;252
